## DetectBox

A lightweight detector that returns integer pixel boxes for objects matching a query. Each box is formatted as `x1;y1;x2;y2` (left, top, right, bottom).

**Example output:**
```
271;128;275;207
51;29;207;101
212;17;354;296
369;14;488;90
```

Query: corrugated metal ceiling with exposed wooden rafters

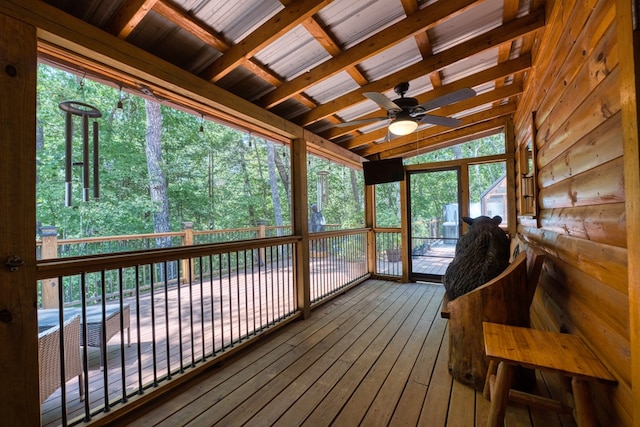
37;0;544;157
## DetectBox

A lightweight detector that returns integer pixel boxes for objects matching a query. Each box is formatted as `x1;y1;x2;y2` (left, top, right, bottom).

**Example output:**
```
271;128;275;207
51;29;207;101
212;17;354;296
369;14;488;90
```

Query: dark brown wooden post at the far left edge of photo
0;10;40;426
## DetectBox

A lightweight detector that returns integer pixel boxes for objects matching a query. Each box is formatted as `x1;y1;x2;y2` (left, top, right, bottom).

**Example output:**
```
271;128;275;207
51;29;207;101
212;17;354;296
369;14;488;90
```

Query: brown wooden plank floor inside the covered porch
116;280;575;427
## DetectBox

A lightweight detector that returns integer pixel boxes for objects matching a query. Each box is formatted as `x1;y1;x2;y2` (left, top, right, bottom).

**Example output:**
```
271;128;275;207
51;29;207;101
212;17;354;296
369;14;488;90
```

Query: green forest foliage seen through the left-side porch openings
36;64;364;238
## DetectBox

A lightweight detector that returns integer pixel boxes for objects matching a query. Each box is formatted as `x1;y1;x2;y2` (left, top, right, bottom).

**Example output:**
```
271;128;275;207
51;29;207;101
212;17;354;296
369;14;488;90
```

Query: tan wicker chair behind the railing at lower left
38;316;84;403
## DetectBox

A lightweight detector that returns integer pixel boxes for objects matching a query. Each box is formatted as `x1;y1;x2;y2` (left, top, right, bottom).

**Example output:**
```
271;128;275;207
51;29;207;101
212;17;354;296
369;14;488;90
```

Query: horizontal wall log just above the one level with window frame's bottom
538;157;625;209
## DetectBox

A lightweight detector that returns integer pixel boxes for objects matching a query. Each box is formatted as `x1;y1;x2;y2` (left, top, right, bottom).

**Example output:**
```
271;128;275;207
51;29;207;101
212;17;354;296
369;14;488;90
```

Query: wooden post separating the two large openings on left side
291;138;311;319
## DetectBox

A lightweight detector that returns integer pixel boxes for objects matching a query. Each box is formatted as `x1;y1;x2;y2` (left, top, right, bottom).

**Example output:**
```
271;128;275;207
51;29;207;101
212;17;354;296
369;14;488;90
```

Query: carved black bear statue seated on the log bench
443;215;509;300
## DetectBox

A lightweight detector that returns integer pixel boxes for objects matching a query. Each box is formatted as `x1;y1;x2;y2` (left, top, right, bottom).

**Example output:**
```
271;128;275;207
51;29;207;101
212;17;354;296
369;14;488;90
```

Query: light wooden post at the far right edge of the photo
616;0;640;425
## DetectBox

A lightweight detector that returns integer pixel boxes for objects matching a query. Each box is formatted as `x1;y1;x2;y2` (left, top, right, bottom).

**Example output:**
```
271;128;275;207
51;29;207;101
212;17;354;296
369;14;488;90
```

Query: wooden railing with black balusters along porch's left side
37;229;370;425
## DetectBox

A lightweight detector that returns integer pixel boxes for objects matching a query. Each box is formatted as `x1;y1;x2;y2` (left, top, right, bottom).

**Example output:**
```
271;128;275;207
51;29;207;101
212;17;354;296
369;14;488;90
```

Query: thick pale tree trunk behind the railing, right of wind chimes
145;100;171;247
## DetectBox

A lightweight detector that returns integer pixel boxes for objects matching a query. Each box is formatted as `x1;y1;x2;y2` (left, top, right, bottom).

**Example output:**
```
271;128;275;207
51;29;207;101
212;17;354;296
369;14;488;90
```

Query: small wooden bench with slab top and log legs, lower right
483;323;617;427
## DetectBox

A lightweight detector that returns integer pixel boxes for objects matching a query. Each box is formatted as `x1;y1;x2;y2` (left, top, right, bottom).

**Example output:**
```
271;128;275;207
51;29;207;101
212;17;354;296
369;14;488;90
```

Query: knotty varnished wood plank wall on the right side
514;0;633;426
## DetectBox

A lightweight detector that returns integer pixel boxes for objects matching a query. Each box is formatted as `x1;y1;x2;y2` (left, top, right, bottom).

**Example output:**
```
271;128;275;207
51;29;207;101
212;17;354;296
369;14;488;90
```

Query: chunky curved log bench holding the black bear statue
441;249;544;391
